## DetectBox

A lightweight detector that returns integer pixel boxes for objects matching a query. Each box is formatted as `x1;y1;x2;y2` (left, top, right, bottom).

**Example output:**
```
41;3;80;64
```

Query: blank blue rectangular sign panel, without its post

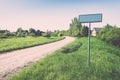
79;14;102;23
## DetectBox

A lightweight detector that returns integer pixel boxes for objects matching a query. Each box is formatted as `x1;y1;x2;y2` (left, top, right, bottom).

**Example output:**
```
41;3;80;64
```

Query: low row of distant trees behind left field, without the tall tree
0;28;63;38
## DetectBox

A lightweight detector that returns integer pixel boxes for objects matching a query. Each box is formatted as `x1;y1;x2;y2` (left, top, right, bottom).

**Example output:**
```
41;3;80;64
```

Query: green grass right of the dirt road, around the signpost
8;38;120;80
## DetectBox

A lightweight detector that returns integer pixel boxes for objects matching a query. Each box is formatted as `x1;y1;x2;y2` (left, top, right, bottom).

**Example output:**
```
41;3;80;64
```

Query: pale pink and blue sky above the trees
0;0;120;31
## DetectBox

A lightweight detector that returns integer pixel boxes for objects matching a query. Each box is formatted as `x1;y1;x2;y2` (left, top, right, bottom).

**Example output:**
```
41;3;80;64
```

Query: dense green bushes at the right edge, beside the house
97;28;120;47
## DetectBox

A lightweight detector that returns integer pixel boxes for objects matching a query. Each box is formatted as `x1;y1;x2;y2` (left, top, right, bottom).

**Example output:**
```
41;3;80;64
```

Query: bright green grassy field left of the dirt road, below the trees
0;37;63;53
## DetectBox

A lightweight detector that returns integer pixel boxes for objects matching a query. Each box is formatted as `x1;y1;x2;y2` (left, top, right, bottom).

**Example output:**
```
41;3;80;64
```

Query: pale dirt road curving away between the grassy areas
0;37;74;80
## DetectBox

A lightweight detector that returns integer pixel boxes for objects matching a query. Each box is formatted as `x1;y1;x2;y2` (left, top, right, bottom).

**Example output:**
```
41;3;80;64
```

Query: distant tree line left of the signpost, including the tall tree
0;17;91;38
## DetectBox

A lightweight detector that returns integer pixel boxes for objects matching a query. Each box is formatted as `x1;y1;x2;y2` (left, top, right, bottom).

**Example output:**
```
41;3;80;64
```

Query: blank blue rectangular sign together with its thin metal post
79;14;102;66
